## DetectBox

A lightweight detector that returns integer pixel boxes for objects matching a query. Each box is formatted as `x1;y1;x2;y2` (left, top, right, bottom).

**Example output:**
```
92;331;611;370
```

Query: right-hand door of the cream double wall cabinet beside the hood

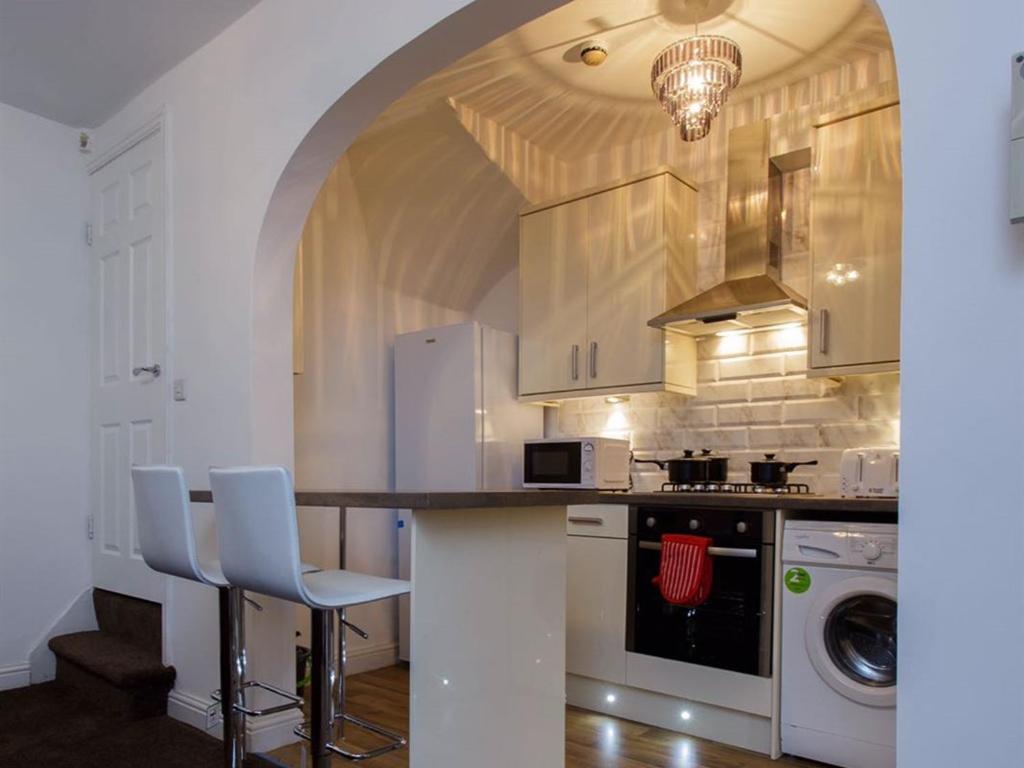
587;176;666;389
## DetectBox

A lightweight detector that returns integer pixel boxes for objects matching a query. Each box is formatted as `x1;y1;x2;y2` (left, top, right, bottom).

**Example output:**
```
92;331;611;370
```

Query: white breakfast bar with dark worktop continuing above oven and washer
191;490;896;768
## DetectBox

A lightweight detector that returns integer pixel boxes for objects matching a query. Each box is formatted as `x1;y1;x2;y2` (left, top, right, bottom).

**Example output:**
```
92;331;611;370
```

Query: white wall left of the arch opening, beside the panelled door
94;0;558;749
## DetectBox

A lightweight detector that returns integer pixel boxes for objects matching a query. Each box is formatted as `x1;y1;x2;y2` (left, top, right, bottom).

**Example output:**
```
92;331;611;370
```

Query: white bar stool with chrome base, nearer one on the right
210;467;410;768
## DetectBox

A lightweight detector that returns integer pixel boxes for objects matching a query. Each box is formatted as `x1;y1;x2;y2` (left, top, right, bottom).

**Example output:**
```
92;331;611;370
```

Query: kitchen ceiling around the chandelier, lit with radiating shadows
370;0;891;160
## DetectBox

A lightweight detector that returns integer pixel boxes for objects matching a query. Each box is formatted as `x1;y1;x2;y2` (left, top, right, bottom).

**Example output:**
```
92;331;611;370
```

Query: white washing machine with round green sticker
781;520;897;768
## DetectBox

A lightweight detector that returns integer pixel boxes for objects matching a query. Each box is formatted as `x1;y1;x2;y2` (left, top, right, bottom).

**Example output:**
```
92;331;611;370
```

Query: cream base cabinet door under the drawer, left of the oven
565;536;629;683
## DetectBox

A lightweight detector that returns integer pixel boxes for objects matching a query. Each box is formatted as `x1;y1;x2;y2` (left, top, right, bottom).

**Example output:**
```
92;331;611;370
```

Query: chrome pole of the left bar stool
217;587;246;768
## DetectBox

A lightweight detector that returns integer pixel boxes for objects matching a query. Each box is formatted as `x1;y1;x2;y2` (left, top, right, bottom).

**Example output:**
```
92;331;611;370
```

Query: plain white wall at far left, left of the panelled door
0;104;92;688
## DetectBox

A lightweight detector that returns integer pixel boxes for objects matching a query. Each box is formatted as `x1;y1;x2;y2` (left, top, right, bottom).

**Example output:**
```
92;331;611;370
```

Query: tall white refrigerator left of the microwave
394;323;544;660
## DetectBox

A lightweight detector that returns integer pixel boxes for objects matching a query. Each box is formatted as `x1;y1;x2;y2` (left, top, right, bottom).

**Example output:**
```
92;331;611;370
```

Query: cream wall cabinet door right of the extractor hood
808;106;902;369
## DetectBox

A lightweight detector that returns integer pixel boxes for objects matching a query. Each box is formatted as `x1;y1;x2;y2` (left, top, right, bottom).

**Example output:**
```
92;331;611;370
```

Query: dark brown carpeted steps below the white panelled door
49;589;175;720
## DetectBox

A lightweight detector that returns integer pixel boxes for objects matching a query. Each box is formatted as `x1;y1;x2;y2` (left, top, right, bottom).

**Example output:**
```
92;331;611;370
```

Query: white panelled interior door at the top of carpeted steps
92;130;168;602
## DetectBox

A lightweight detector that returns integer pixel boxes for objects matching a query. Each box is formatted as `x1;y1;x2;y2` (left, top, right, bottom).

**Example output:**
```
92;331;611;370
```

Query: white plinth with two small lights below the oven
565;675;771;755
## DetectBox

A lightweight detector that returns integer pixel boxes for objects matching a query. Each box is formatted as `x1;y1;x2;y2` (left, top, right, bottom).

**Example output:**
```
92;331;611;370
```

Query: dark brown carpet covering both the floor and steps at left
0;589;280;768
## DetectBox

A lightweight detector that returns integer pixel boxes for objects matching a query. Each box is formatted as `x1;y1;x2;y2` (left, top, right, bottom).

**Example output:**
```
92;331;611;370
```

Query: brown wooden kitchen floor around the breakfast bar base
271;667;821;768
